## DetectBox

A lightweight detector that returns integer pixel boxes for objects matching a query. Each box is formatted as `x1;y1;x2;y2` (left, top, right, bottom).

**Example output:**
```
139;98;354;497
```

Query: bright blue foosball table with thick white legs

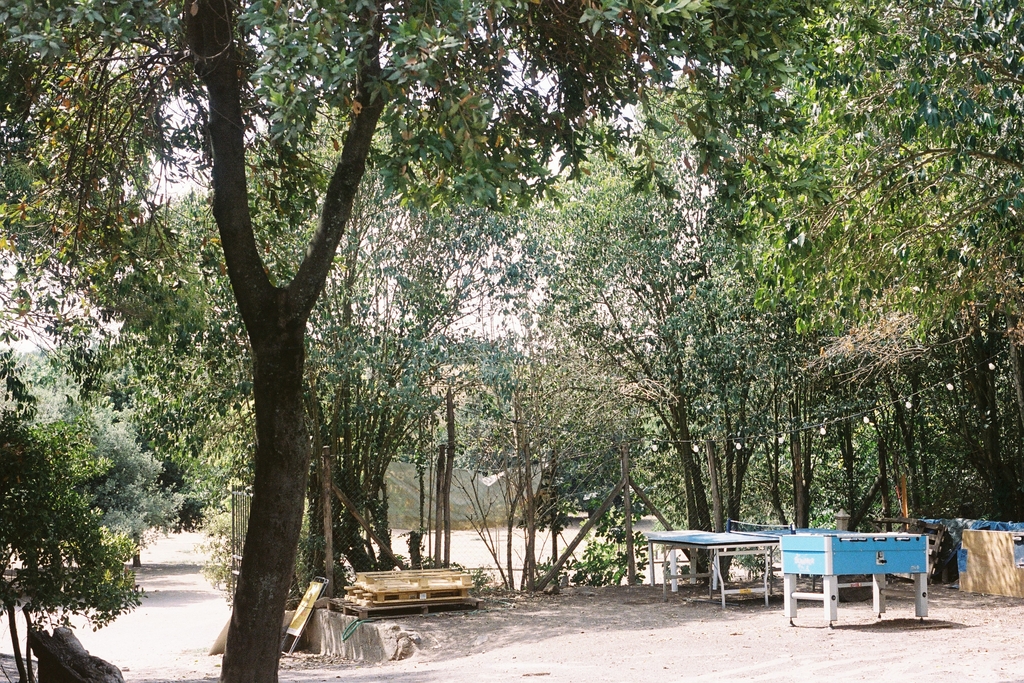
780;532;928;628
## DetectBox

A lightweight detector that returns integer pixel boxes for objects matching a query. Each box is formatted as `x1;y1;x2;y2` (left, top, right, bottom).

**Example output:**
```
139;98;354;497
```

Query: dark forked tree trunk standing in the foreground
182;0;383;683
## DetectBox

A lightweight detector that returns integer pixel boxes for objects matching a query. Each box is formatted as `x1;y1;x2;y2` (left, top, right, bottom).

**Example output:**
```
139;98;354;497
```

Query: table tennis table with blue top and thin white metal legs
646;529;786;608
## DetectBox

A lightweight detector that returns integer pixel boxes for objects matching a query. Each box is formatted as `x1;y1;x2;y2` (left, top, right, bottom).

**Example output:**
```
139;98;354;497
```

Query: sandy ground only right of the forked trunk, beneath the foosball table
282;587;1024;683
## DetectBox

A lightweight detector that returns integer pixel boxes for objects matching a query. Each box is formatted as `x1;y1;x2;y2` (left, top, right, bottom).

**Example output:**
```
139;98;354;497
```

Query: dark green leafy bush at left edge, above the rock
0;411;139;671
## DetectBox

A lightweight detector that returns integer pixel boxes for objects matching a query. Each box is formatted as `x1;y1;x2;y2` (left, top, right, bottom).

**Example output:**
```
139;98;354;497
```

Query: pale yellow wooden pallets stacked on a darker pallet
345;569;473;607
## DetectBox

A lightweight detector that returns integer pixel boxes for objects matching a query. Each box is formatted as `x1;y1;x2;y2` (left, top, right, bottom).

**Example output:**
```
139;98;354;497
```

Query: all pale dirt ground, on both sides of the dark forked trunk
0;535;1024;683
